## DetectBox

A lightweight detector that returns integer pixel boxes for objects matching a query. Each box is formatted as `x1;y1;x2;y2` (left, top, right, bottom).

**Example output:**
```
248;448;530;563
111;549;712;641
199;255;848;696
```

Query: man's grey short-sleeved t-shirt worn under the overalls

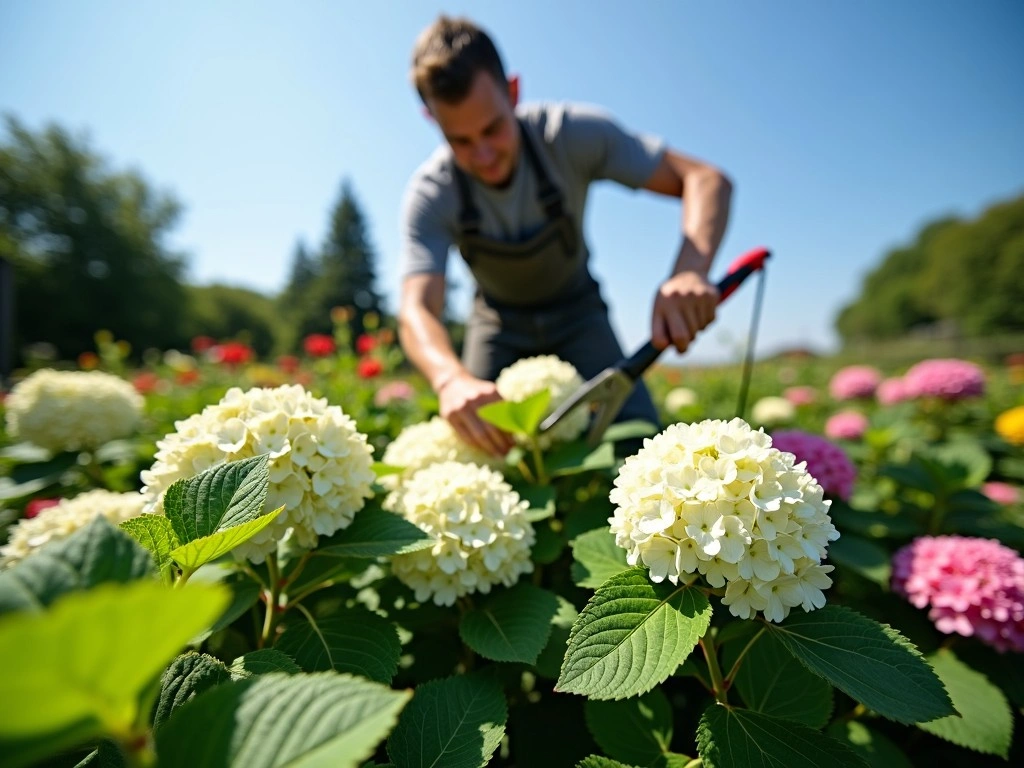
400;97;665;299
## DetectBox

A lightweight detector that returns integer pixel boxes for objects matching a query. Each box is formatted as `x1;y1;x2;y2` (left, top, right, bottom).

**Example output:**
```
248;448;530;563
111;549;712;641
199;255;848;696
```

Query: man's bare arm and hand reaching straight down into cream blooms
398;273;512;456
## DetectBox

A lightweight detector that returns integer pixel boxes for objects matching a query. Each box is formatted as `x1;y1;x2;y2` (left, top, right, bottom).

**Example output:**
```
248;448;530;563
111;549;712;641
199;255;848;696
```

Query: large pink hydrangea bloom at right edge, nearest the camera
892;536;1024;653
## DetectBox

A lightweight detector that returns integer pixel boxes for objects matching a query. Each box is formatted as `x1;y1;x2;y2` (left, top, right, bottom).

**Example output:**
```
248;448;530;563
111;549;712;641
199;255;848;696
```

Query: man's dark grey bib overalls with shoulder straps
453;121;659;434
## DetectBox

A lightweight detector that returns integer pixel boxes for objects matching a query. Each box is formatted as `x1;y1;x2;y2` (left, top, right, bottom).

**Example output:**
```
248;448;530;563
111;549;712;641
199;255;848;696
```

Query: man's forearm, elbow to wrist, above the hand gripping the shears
672;169;732;278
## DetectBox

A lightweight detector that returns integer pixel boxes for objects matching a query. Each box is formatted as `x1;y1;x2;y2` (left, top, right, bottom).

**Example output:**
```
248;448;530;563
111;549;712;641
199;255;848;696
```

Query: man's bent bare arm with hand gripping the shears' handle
644;150;732;352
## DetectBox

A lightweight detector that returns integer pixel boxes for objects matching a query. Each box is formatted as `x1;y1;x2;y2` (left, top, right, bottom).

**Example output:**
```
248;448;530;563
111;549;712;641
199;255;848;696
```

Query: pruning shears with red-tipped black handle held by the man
539;248;771;447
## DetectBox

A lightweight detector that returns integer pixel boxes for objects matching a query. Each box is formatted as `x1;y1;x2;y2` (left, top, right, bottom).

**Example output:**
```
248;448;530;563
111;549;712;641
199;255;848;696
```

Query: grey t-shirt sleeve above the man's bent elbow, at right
561;104;666;189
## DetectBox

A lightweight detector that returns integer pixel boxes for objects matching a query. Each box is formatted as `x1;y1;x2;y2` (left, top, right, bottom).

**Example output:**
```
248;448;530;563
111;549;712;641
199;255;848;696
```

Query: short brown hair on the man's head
412;15;506;103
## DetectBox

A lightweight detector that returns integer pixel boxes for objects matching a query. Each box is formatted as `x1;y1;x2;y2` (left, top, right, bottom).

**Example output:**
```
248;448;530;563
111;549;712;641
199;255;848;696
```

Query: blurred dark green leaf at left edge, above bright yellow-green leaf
0;516;154;614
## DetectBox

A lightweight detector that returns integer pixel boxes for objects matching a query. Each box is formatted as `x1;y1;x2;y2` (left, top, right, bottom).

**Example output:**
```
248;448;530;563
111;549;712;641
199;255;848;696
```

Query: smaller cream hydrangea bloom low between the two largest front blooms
384;462;536;605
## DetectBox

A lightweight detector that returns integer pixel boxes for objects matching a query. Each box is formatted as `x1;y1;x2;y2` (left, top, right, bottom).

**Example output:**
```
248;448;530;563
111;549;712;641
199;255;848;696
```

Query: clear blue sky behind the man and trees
0;0;1024;362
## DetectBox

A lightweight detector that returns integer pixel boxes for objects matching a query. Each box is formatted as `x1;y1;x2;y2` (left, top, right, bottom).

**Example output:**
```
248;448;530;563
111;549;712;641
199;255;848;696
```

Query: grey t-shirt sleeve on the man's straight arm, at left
399;176;453;278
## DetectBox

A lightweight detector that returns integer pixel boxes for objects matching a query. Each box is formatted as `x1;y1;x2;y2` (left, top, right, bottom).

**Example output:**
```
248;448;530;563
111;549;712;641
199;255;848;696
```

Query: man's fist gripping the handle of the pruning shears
650;269;719;352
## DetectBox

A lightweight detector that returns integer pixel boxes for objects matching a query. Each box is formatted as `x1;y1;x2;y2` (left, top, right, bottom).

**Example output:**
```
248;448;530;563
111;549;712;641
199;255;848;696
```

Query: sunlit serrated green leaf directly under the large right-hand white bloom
555;568;712;698
